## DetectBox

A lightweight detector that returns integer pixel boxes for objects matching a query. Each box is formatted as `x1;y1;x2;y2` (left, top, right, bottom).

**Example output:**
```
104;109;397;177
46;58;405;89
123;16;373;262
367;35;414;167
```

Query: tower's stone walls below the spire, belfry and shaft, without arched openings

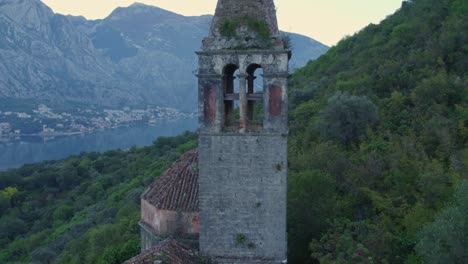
198;50;289;264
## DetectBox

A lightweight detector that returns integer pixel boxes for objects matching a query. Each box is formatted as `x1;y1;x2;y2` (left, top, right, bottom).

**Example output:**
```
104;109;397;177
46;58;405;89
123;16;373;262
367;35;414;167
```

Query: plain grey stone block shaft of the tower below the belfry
199;133;287;263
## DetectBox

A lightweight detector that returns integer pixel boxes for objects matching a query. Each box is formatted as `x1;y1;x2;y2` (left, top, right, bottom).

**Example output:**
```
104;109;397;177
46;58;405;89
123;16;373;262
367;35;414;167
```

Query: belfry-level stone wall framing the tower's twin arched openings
198;50;289;134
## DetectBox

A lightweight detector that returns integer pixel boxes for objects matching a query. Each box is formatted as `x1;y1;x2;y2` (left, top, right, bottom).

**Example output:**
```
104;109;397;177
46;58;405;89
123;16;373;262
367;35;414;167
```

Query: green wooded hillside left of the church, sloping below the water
0;133;197;264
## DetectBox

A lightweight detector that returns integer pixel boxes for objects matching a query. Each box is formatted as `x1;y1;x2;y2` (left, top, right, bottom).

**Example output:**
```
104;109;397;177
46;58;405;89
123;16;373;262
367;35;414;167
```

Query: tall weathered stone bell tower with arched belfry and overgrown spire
197;0;291;264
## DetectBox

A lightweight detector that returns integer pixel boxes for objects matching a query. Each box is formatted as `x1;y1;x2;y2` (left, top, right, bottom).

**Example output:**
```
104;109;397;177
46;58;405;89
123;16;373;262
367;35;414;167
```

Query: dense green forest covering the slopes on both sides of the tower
0;0;468;264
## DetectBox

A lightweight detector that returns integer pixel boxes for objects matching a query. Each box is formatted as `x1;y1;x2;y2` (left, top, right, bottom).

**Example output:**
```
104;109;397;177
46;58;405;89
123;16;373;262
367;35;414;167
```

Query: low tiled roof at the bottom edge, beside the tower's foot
124;239;198;264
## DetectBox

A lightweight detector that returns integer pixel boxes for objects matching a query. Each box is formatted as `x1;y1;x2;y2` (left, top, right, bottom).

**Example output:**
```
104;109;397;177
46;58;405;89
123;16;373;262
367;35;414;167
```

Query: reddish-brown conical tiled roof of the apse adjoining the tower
141;150;198;212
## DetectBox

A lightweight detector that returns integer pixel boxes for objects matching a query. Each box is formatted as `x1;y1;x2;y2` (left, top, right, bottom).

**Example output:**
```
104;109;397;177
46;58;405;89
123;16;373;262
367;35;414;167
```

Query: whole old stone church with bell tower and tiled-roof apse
126;0;291;264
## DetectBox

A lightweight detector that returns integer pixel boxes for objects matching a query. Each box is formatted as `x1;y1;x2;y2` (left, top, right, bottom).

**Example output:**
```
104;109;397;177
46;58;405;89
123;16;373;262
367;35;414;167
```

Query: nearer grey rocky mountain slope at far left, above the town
0;0;142;105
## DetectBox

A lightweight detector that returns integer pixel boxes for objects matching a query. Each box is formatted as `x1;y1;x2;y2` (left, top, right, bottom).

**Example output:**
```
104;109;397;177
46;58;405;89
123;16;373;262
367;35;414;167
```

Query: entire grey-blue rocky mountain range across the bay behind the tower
0;0;327;110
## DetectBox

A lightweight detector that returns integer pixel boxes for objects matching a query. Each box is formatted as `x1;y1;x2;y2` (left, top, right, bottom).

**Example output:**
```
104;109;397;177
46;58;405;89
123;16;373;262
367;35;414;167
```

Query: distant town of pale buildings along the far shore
0;104;196;138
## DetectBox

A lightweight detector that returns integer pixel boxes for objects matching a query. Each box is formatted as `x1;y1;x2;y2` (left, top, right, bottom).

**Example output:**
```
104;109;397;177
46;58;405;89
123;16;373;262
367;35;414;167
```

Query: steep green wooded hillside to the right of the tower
288;0;468;263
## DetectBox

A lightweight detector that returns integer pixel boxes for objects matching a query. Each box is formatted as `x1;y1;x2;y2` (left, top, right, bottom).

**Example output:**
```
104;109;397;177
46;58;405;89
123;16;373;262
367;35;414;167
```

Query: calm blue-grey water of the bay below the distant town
0;118;197;171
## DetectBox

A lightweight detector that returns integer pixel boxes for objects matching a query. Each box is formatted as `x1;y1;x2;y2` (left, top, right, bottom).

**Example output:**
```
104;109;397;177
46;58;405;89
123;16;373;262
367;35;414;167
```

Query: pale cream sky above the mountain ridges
42;0;402;45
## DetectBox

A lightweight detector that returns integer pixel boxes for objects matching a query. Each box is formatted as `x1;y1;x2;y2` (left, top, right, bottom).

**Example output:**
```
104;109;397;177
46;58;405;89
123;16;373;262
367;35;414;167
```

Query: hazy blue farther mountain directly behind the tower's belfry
73;3;328;110
